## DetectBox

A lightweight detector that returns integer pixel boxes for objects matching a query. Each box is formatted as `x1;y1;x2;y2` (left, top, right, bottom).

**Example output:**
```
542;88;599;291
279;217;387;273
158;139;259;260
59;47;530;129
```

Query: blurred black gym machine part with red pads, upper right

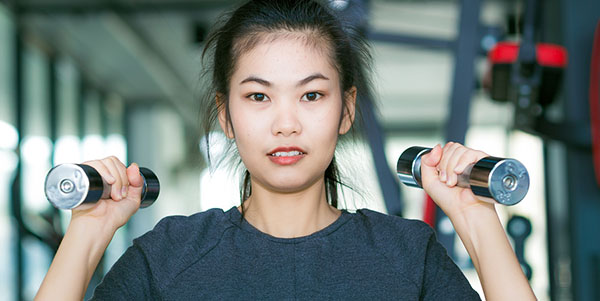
484;0;573;135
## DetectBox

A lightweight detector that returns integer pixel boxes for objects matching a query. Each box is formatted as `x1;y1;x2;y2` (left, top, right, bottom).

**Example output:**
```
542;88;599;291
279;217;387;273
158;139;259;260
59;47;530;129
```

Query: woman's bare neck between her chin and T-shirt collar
243;180;341;238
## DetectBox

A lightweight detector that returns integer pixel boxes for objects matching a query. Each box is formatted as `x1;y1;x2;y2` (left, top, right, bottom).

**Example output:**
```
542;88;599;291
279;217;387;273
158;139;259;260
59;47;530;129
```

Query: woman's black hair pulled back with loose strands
202;0;371;212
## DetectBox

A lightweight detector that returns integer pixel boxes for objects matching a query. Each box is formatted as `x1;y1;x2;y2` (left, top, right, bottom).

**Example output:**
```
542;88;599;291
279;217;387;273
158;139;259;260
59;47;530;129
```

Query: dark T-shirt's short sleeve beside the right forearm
421;233;481;300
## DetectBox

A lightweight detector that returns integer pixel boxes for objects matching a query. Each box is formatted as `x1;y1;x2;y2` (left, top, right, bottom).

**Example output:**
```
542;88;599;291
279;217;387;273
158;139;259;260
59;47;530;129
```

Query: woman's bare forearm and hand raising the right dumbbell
421;143;536;300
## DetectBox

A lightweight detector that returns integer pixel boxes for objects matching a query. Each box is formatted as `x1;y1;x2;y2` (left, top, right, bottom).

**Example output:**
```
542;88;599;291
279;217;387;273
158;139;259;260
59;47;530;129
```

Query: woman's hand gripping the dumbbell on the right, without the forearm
421;142;493;218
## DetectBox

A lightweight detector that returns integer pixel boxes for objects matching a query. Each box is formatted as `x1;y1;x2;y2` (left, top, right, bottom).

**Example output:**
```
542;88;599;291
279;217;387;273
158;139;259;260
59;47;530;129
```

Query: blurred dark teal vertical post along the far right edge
556;0;600;300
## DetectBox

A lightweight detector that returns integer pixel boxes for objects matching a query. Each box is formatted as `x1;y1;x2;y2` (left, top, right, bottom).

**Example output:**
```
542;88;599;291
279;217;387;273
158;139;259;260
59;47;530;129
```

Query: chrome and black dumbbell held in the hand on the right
396;146;529;206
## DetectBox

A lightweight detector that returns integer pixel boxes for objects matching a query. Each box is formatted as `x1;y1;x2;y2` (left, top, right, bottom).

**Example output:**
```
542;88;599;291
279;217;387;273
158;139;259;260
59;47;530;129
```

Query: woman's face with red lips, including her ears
219;34;355;192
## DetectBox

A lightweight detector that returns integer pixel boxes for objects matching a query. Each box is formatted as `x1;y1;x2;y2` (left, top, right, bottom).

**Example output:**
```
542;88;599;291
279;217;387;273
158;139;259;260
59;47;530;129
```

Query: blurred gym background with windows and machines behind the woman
0;0;600;300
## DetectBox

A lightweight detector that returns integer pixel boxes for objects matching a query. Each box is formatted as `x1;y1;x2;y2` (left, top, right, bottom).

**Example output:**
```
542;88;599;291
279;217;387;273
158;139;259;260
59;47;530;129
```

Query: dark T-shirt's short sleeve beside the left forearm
91;244;158;300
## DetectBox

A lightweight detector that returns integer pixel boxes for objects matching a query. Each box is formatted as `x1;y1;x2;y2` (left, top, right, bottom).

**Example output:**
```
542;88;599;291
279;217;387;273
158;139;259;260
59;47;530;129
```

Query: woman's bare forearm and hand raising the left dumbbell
35;157;143;300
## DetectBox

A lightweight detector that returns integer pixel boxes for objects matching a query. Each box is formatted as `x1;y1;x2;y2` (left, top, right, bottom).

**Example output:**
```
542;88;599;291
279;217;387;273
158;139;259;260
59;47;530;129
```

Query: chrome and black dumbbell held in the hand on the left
45;164;160;209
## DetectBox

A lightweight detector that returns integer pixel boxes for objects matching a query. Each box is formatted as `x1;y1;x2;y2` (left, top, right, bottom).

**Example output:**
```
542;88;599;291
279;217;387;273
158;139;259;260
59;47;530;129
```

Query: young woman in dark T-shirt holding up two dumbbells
37;0;535;300
